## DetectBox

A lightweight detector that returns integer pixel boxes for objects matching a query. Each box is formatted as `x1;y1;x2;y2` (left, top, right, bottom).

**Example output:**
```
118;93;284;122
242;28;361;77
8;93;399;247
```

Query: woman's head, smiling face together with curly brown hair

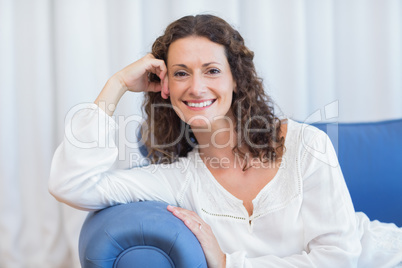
142;15;286;169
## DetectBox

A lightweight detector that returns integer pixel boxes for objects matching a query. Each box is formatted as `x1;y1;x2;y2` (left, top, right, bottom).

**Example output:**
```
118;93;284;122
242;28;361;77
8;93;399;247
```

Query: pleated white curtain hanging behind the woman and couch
0;0;402;268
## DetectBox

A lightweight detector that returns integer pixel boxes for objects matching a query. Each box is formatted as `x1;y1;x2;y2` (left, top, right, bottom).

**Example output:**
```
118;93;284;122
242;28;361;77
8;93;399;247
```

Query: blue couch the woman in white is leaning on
79;119;402;268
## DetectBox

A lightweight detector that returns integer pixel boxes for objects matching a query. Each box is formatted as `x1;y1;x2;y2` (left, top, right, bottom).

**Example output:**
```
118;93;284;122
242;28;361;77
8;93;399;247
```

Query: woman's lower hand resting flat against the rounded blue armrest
167;205;226;268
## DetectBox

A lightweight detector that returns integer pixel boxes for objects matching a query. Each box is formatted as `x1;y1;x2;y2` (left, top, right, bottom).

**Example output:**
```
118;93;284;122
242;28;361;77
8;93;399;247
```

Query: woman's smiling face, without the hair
167;36;236;128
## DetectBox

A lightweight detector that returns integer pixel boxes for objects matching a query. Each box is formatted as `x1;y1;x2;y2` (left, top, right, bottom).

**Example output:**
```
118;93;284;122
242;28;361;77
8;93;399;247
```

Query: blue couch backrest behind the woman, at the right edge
314;119;402;226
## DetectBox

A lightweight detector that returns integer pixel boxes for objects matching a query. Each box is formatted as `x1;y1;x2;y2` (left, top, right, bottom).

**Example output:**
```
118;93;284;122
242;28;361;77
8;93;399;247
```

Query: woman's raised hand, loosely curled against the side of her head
114;54;168;99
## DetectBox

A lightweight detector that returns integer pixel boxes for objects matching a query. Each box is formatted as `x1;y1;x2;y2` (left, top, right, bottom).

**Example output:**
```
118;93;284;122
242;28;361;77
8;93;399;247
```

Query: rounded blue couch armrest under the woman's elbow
79;201;207;268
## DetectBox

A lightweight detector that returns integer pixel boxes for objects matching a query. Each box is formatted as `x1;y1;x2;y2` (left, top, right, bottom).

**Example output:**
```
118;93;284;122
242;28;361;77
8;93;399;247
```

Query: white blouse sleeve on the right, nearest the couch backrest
226;131;361;268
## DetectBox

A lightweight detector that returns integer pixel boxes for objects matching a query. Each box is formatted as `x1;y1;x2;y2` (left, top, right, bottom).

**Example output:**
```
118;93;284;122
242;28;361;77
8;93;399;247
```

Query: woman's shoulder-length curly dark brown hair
142;15;284;169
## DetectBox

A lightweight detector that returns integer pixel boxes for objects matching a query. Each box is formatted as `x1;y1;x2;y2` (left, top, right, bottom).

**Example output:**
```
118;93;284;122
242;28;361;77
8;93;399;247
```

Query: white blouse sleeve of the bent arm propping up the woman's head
49;104;186;210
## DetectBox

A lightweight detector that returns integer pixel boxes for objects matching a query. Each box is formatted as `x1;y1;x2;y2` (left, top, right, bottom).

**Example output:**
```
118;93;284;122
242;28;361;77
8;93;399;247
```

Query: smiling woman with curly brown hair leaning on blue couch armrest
49;15;402;267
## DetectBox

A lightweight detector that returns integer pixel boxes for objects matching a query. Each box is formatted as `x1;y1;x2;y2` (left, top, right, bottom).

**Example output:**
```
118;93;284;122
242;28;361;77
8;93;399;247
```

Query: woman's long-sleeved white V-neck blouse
49;104;402;268
